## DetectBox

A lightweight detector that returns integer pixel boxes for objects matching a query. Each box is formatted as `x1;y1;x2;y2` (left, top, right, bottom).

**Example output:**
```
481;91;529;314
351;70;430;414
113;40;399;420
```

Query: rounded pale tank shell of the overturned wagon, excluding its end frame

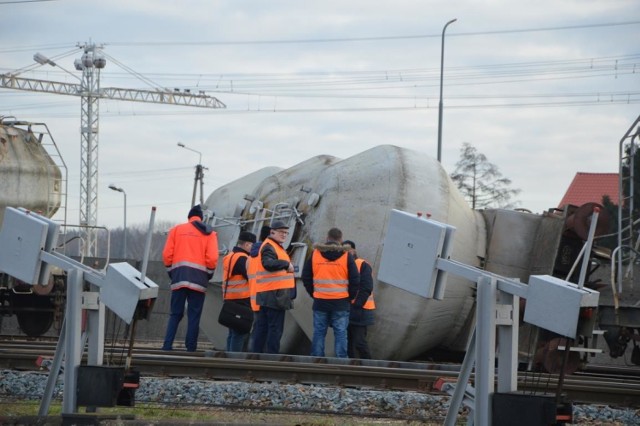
203;145;485;360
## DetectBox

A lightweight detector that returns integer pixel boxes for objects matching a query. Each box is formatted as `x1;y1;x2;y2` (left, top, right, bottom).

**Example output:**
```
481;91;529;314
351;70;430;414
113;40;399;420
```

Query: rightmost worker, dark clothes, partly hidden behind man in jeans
344;240;376;359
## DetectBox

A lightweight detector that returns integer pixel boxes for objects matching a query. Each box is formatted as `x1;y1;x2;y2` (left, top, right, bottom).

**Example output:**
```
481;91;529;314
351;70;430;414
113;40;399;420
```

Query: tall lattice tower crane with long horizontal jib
0;43;226;256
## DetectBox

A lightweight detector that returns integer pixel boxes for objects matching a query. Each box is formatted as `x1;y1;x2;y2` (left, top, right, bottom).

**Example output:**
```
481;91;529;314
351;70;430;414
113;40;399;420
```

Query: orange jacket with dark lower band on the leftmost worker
162;216;218;293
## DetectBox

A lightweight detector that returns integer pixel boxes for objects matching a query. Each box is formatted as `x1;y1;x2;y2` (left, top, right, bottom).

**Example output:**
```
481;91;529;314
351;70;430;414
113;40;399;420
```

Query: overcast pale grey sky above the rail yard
0;0;640;227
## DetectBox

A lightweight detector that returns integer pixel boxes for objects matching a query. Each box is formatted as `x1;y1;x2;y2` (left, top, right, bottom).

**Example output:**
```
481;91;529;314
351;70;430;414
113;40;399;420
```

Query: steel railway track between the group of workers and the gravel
0;339;640;407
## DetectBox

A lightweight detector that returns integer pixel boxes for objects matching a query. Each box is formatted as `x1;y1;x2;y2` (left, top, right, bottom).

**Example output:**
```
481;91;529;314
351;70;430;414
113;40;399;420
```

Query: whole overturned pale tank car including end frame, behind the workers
201;145;562;360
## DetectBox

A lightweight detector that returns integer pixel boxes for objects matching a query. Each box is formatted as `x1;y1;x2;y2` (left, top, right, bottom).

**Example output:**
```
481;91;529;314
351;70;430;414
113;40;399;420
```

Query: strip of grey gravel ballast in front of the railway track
0;370;640;425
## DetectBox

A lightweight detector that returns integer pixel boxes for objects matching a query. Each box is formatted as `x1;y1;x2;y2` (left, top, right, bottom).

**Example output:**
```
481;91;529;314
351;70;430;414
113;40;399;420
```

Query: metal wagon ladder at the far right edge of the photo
615;116;640;291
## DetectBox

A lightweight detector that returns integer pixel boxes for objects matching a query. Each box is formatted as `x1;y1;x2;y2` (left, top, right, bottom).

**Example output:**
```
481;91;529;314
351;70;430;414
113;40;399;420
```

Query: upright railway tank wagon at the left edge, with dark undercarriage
0;118;65;336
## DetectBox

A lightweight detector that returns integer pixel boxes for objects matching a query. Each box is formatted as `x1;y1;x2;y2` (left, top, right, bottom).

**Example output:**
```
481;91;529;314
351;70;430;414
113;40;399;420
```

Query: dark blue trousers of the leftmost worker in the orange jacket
162;288;205;352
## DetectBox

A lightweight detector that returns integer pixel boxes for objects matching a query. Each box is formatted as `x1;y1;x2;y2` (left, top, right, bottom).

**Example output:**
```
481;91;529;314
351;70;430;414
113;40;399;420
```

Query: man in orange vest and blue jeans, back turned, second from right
302;228;360;358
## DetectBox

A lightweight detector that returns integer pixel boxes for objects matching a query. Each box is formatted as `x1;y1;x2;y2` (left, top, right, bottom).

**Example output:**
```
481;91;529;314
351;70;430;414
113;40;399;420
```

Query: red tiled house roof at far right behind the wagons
558;172;618;208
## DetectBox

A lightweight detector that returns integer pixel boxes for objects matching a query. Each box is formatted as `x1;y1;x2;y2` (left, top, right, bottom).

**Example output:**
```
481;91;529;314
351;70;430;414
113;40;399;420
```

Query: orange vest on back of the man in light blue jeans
311;249;349;299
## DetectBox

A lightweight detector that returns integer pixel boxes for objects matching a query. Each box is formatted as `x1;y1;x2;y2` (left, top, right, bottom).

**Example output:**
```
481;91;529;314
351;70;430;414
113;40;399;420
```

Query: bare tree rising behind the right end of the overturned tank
451;142;520;209
